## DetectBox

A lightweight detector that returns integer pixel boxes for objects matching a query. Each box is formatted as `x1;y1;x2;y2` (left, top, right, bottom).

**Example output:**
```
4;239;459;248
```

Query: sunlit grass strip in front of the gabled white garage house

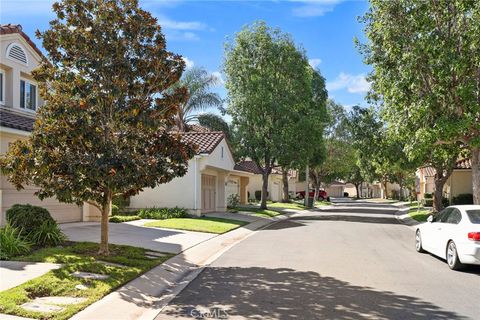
145;217;248;234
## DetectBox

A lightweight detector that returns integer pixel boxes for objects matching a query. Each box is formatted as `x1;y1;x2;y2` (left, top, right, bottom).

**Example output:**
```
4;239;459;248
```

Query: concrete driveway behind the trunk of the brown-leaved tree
60;219;216;253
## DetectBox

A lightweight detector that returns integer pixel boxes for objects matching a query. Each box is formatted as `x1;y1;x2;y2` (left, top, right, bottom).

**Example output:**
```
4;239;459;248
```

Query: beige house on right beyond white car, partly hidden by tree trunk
416;158;473;201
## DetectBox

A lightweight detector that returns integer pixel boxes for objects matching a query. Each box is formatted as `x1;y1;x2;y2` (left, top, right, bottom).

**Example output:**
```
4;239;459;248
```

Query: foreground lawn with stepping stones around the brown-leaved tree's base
0;242;172;319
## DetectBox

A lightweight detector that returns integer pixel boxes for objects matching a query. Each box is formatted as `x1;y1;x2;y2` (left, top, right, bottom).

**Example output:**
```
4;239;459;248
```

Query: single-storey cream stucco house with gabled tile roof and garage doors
130;131;253;215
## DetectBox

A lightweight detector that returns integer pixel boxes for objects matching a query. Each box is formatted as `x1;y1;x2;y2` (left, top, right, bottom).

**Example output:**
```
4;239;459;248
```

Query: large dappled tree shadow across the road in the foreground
162;267;465;319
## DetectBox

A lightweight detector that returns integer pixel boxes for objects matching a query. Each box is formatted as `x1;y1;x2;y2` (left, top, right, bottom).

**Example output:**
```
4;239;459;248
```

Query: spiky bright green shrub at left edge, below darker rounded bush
0;224;30;260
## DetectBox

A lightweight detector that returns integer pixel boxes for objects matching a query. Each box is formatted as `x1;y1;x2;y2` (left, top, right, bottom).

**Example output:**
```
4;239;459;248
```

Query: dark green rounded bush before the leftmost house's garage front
7;204;55;236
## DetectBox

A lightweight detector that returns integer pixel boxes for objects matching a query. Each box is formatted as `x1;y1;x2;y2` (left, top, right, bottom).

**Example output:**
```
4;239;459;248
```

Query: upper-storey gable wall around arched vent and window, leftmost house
0;33;43;112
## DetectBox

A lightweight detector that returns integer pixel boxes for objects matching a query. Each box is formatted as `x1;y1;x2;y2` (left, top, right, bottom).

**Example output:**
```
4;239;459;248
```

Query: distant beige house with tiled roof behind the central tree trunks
235;160;297;201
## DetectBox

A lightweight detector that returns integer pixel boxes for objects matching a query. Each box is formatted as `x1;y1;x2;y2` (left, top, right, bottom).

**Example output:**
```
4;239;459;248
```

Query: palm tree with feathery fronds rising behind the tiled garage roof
175;68;223;131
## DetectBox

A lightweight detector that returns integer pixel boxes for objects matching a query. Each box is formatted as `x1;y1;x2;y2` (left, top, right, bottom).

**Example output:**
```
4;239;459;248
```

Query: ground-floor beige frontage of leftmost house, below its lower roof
0;132;84;225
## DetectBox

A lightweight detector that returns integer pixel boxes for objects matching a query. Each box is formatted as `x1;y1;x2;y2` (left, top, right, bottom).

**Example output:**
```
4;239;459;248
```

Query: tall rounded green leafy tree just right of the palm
224;22;311;208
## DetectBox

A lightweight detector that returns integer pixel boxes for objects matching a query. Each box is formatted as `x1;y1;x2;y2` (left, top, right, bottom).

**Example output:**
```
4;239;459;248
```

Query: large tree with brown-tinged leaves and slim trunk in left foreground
1;0;193;255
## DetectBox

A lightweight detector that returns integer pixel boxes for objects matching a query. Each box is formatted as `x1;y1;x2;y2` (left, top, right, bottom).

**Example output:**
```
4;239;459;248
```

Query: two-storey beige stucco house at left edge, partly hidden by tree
0;25;98;225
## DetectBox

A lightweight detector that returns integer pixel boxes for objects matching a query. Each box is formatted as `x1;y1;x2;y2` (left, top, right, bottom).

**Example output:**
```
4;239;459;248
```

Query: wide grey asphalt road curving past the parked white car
157;203;480;319
